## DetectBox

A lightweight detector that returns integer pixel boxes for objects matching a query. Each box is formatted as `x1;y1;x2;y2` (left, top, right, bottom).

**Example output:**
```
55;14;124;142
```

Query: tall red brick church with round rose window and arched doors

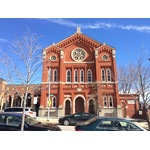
40;28;127;117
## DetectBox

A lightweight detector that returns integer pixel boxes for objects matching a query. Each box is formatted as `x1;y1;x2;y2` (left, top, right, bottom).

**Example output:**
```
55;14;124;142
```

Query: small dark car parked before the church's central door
58;112;95;126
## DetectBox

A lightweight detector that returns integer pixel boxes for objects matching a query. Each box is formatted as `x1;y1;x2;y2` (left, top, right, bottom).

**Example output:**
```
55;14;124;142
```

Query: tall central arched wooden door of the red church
75;97;84;113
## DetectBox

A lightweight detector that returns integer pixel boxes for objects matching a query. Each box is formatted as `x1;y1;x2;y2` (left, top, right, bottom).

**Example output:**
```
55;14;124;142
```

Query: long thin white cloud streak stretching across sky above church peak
41;18;150;33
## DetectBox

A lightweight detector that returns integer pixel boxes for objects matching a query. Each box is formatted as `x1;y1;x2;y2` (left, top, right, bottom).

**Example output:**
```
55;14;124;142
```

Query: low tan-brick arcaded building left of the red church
0;79;41;110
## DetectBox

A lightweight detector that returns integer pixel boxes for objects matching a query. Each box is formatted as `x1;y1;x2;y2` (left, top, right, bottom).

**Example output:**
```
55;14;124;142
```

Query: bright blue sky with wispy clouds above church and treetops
0;18;150;66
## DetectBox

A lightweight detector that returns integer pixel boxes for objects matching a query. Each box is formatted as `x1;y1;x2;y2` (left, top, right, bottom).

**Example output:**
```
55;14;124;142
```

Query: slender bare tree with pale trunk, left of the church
0;29;42;131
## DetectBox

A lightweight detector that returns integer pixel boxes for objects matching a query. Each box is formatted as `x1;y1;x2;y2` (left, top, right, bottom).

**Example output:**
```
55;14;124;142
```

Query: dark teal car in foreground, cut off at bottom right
75;117;147;131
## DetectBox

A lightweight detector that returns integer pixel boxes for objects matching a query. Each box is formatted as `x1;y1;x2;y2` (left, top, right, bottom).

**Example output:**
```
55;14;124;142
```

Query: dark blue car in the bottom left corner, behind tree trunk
0;112;61;131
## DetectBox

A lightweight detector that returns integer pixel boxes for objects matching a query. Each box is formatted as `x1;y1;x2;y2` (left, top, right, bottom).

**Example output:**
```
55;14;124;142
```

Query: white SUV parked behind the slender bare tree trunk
2;107;36;117
